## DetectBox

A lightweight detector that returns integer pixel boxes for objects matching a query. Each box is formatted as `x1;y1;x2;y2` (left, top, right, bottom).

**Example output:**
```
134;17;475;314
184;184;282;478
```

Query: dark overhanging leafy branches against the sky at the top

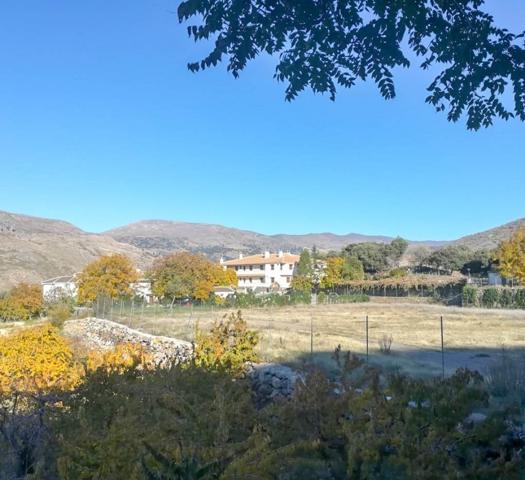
178;0;525;130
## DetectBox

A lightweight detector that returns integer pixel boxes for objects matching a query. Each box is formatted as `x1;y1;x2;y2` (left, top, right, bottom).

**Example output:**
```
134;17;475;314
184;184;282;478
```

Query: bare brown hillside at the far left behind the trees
0;211;149;292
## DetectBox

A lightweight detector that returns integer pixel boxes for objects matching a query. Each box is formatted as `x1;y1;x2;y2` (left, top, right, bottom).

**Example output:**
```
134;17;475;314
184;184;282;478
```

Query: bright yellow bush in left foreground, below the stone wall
0;325;84;395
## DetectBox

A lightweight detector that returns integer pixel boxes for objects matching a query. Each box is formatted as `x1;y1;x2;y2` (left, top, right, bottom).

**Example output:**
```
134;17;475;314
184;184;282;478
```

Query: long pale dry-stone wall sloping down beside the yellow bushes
64;318;193;367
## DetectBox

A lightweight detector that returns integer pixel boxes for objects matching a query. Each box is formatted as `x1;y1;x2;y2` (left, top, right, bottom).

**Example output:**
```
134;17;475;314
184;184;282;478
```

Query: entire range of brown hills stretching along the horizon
0;211;525;291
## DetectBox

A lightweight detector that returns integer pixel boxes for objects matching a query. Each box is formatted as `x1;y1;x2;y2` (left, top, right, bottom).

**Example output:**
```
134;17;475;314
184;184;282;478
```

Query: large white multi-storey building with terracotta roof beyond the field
221;252;299;292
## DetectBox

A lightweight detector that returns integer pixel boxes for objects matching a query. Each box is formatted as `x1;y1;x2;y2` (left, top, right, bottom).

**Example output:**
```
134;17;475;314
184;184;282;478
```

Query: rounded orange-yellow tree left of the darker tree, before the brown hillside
77;254;138;303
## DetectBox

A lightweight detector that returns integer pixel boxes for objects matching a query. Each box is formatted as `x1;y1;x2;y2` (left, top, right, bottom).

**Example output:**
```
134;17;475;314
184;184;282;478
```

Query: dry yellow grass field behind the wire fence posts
114;299;525;376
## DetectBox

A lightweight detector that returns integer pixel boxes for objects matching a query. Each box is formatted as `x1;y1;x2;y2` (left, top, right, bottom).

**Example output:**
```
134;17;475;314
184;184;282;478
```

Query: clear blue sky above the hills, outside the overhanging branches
0;0;525;239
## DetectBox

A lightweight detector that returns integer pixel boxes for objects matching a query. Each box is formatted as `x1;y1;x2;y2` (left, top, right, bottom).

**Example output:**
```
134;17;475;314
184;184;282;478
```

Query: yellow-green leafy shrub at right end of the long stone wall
194;310;259;374
